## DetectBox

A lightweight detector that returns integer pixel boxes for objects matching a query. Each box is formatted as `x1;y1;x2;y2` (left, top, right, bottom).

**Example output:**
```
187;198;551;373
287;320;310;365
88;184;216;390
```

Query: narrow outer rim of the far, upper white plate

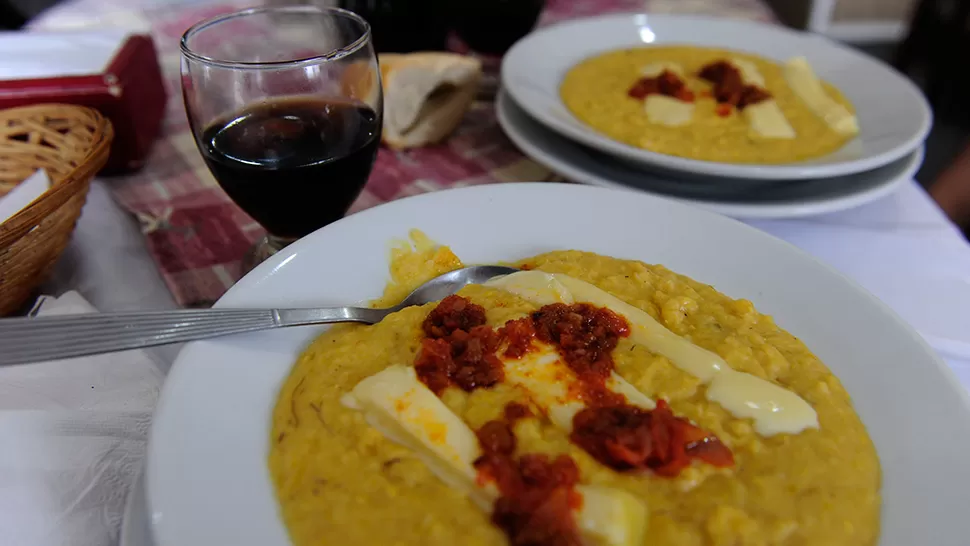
501;12;933;180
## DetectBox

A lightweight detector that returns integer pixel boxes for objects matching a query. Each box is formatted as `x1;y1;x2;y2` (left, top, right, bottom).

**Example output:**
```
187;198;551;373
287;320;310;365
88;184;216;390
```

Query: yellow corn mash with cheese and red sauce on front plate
269;234;880;546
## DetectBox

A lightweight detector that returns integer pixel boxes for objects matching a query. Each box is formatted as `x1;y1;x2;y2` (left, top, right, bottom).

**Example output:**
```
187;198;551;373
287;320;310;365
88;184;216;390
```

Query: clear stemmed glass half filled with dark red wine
181;6;383;271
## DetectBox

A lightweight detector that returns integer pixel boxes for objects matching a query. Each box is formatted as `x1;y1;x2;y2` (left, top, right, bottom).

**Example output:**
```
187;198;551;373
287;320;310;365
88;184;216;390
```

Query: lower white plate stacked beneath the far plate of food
495;88;925;220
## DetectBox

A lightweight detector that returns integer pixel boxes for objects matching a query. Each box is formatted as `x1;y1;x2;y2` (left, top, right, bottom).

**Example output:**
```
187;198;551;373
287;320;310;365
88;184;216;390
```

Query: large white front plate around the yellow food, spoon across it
147;184;970;546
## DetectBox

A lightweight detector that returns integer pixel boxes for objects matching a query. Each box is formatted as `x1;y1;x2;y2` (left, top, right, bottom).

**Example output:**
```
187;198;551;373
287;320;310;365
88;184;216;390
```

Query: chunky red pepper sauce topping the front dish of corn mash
415;296;734;478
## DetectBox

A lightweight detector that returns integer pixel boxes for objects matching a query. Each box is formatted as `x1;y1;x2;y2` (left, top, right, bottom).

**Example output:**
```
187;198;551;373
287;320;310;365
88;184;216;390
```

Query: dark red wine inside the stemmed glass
201;99;381;238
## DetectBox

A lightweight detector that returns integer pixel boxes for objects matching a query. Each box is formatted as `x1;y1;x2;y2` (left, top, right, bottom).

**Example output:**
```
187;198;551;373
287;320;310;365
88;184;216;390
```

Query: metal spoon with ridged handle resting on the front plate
0;265;518;366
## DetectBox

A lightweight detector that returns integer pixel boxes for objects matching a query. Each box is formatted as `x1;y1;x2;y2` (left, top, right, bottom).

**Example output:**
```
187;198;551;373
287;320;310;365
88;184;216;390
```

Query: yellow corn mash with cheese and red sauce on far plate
560;46;859;164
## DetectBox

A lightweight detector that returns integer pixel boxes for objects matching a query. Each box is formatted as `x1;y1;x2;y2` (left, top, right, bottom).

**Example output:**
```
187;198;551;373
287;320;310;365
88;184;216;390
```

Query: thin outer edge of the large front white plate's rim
145;182;970;546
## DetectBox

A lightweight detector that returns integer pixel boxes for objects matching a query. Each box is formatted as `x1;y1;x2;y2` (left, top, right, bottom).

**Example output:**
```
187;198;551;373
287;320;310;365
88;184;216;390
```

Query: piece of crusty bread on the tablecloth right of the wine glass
380;53;482;149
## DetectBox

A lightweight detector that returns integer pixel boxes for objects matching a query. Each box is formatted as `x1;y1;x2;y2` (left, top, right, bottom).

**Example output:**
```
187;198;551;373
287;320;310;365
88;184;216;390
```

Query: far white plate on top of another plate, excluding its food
502;14;932;180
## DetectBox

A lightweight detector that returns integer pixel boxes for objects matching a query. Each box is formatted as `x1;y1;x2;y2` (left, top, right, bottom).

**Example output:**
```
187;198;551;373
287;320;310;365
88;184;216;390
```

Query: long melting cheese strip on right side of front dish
486;271;818;436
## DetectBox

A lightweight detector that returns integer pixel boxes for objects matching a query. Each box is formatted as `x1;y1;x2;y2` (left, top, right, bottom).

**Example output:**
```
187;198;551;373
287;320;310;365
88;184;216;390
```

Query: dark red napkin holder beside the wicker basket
0;35;168;174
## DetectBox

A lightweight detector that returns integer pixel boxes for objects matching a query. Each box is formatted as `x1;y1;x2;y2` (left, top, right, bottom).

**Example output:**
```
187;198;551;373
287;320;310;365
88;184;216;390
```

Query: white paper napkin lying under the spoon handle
0;292;163;546
